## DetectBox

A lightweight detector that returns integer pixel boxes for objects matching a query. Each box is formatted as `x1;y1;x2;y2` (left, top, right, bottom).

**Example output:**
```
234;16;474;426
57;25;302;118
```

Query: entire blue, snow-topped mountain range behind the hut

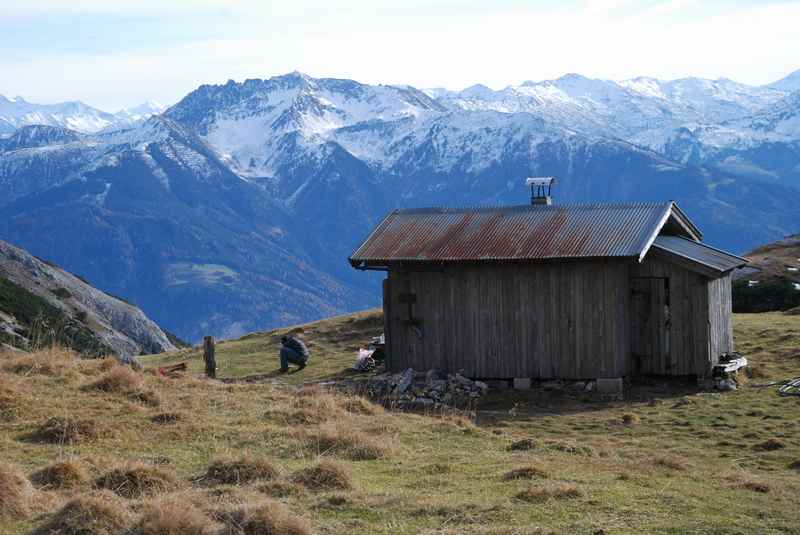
0;71;800;340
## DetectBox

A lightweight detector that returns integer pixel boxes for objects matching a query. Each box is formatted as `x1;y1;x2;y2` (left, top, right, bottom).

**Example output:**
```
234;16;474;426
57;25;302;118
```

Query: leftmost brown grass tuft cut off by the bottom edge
33;493;130;535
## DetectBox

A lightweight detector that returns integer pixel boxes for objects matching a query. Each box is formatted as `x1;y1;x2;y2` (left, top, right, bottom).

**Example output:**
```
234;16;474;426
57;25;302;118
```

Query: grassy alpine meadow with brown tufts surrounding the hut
0;312;800;535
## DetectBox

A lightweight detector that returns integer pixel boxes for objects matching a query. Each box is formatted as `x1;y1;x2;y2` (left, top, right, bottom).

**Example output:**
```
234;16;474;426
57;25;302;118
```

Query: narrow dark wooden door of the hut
631;277;670;375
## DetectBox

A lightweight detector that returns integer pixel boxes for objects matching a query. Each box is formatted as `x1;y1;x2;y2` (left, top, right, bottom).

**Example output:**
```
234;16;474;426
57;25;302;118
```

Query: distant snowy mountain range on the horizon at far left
0;95;165;137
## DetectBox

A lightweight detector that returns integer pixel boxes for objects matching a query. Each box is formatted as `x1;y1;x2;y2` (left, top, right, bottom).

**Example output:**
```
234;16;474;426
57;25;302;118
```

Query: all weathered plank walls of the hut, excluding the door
384;258;732;379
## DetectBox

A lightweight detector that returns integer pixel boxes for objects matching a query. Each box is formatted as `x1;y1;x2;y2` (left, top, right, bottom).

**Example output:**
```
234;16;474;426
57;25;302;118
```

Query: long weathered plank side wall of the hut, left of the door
384;259;630;379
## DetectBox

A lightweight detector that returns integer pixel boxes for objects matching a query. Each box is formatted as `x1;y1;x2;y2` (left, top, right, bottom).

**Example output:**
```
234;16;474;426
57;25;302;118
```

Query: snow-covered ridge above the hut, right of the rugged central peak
434;74;786;149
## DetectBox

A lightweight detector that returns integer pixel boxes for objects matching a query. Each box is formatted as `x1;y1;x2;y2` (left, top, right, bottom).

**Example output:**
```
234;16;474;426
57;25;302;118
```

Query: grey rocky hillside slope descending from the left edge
0;241;175;355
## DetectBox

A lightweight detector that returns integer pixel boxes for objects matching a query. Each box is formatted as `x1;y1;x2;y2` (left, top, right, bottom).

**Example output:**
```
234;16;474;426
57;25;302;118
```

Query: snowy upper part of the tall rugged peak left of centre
166;72;446;177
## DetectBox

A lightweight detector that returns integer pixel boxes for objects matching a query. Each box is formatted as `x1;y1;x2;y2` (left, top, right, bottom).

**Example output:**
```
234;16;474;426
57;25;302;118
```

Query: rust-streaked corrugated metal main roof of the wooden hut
350;202;694;267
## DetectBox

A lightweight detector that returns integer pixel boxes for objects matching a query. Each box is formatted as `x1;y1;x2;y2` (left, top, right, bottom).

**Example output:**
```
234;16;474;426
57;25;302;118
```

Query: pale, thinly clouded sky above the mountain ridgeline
0;0;800;111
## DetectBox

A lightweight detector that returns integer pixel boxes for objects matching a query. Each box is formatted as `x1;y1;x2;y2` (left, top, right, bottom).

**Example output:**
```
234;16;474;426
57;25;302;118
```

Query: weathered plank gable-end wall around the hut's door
630;256;710;376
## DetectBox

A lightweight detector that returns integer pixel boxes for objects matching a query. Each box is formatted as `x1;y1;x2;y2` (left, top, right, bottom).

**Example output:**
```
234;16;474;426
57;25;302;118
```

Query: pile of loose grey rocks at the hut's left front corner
367;368;489;408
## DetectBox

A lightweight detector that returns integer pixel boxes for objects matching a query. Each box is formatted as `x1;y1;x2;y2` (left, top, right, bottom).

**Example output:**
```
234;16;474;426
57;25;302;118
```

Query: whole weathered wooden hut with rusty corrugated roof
349;186;746;380
